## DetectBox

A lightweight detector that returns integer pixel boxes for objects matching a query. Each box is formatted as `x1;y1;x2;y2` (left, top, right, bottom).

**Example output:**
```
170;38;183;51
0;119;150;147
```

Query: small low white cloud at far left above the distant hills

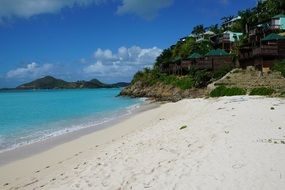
6;62;53;78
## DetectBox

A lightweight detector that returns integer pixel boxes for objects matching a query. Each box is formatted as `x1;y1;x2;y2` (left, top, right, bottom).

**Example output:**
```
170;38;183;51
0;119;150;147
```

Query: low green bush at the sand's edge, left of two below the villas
210;86;246;97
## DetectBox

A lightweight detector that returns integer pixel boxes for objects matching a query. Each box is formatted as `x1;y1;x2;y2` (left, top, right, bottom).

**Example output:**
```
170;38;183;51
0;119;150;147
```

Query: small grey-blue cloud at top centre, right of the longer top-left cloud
117;0;173;20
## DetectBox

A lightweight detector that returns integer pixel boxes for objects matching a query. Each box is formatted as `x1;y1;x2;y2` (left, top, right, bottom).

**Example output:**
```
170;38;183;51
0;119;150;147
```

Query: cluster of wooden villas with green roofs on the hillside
161;14;285;75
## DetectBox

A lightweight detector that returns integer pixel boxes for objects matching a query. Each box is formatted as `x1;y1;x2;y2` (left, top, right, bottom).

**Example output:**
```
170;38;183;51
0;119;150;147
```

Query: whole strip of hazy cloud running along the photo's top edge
0;0;173;23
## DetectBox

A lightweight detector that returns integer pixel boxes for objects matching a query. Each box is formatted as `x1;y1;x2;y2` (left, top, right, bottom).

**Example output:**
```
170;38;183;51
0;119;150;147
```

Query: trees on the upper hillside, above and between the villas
155;0;285;68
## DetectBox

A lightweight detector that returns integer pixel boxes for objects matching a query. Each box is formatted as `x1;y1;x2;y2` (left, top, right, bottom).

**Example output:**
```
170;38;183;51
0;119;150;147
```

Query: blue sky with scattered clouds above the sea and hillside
0;0;256;88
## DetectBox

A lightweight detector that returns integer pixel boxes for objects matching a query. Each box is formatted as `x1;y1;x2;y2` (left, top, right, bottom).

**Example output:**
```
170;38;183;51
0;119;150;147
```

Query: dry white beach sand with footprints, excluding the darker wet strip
0;96;285;190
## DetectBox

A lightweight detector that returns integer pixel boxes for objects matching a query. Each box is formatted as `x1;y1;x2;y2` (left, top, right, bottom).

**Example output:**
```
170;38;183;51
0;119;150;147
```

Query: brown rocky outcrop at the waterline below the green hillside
120;81;205;102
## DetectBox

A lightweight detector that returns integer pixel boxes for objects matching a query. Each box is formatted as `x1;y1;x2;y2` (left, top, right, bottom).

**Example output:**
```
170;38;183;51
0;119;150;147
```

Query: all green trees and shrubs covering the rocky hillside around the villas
132;0;285;91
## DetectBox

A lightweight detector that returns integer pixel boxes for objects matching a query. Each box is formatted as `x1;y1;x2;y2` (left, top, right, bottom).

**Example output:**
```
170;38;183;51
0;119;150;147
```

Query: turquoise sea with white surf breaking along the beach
0;88;142;152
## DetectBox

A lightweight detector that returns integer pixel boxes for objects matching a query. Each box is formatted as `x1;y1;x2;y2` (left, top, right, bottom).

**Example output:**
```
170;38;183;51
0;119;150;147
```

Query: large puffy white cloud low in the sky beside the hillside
83;46;162;77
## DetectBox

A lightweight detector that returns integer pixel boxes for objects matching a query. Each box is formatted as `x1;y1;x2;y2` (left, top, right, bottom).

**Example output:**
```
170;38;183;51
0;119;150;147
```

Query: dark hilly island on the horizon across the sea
0;76;129;90
